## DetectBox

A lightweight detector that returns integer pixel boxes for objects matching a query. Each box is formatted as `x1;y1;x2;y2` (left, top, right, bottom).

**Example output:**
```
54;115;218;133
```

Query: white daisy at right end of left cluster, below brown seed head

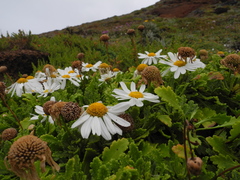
57;67;80;89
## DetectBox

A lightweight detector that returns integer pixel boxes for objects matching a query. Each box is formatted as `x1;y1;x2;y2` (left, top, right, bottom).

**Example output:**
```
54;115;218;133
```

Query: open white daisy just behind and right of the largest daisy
112;82;160;107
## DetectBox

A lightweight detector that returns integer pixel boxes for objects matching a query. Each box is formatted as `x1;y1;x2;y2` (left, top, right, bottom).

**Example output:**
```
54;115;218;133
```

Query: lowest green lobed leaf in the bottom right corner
210;154;239;169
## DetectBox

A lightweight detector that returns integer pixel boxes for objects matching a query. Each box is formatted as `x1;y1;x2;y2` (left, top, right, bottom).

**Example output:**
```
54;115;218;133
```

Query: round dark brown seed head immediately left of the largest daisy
61;102;82;122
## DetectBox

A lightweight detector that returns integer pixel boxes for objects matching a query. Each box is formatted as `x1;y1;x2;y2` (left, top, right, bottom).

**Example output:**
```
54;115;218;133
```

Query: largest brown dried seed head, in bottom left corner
5;135;60;180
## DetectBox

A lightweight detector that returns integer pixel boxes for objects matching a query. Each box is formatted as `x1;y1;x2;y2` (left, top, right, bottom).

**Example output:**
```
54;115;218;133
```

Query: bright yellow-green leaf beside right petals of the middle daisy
154;86;182;111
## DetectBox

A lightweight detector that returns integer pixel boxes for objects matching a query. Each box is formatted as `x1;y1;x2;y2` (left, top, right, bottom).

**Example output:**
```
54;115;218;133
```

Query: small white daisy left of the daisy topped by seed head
138;49;167;65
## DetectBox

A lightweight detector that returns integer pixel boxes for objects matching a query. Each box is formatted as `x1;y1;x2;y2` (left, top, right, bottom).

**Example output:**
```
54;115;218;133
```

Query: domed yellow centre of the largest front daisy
86;102;108;117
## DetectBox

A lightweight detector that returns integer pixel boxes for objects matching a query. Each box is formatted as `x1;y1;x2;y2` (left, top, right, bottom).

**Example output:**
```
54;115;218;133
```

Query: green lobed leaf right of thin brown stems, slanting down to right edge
206;135;237;159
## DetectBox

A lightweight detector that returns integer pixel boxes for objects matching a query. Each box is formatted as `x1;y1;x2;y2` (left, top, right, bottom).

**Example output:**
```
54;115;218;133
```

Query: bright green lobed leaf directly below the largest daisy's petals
102;138;129;162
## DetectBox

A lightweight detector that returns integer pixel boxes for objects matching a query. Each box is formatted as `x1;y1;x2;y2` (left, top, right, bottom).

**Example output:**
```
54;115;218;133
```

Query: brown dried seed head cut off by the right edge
220;54;240;73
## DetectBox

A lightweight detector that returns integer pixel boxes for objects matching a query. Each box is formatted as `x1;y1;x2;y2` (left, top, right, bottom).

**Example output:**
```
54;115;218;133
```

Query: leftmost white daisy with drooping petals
8;76;41;97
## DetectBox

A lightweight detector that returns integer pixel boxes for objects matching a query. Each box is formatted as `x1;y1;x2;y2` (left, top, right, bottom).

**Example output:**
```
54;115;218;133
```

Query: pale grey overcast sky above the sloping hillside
0;0;159;36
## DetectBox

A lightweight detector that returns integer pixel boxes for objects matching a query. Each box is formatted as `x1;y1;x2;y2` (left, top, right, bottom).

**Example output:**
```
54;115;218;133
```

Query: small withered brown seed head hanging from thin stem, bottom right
187;157;203;175
